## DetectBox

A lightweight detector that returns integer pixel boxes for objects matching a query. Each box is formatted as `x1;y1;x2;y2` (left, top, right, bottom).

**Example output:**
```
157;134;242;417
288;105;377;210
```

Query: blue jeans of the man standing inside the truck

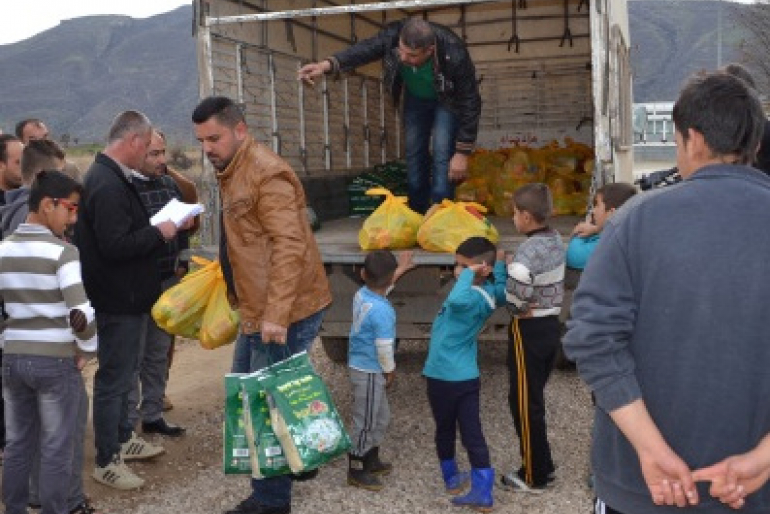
404;92;457;213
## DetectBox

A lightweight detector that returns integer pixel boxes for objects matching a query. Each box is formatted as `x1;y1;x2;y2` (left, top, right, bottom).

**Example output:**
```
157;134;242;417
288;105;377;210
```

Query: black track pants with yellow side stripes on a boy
508;316;561;487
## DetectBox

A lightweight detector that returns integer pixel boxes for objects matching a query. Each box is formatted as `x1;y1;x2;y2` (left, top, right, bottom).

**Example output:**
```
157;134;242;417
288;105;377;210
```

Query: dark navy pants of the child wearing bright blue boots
428;378;491;469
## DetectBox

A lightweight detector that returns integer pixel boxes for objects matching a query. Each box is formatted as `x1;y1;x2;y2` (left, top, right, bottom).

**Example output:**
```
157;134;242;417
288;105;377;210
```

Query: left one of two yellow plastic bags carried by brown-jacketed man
152;258;221;339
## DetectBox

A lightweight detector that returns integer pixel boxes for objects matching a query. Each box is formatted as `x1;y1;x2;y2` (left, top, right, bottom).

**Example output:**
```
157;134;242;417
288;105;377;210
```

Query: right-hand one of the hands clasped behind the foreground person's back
693;447;770;509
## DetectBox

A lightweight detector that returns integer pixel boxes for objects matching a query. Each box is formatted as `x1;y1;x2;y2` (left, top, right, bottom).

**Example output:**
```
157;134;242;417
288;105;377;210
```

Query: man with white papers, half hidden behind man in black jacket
128;130;201;437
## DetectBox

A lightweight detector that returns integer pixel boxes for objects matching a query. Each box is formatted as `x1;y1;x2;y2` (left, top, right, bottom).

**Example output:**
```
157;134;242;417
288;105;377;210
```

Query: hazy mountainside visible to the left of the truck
0;6;198;141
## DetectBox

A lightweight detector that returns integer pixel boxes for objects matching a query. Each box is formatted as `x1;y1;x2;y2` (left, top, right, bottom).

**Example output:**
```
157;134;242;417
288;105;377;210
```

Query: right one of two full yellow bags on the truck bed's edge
417;200;500;253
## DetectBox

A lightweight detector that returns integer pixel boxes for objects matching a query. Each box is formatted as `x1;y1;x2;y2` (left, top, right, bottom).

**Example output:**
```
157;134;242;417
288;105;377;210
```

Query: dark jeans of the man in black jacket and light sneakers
93;313;150;467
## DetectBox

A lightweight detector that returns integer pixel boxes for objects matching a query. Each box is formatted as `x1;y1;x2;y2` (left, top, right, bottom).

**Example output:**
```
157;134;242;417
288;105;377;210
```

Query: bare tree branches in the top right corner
731;0;770;94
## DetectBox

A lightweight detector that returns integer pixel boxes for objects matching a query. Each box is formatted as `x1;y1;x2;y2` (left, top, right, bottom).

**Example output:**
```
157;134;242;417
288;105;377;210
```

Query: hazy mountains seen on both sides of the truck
0;0;744;143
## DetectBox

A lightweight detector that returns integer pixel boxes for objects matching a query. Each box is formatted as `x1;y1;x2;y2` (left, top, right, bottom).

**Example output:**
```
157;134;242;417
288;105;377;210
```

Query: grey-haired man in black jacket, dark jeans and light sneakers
75;111;177;489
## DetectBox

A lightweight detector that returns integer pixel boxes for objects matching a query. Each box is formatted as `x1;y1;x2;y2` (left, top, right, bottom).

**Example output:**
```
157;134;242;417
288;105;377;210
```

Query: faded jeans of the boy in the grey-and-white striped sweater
3;353;81;514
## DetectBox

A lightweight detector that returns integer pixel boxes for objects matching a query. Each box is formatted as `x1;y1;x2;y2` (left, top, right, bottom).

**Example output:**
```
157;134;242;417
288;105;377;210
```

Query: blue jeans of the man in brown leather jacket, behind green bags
232;311;323;507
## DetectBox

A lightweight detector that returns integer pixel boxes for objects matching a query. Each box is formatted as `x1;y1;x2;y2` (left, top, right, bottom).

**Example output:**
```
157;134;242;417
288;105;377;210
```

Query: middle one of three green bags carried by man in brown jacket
241;371;291;479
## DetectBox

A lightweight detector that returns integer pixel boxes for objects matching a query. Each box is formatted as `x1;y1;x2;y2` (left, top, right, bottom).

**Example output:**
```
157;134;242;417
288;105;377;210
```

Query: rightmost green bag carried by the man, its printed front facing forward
257;352;350;473
